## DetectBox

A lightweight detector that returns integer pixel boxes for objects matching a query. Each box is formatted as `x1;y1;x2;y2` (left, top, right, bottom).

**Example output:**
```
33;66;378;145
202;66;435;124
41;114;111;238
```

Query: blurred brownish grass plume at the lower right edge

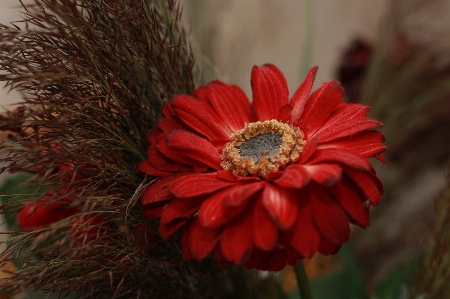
415;164;450;299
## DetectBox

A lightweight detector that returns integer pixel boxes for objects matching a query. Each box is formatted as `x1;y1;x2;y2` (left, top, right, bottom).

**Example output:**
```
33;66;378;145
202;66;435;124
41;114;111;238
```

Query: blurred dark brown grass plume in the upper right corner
361;0;450;179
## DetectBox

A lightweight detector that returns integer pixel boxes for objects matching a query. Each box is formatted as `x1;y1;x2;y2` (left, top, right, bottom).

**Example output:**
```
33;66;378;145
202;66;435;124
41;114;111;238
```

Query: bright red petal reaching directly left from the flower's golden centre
166;130;221;169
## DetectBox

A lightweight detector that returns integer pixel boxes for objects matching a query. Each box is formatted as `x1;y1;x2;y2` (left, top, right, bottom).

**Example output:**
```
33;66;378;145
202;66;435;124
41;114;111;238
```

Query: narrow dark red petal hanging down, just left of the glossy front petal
253;199;278;250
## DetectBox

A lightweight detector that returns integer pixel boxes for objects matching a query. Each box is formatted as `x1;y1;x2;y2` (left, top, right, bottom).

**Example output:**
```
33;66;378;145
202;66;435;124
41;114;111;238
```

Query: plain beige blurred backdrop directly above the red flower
181;0;388;95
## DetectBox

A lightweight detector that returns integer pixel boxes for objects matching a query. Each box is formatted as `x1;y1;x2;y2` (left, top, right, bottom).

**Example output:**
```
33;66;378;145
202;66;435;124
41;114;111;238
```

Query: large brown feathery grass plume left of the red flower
0;0;241;298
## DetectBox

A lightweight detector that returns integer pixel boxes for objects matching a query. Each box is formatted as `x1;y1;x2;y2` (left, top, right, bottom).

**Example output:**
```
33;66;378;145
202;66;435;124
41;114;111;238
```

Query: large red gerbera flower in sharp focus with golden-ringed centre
139;65;386;271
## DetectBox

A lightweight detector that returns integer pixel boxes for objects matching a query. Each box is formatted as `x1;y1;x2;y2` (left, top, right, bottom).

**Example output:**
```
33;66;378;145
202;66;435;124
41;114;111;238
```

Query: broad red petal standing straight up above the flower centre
251;64;289;121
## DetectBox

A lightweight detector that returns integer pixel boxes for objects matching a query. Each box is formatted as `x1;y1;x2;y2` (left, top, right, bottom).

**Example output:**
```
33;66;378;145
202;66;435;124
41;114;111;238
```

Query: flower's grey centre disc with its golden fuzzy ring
220;119;306;178
